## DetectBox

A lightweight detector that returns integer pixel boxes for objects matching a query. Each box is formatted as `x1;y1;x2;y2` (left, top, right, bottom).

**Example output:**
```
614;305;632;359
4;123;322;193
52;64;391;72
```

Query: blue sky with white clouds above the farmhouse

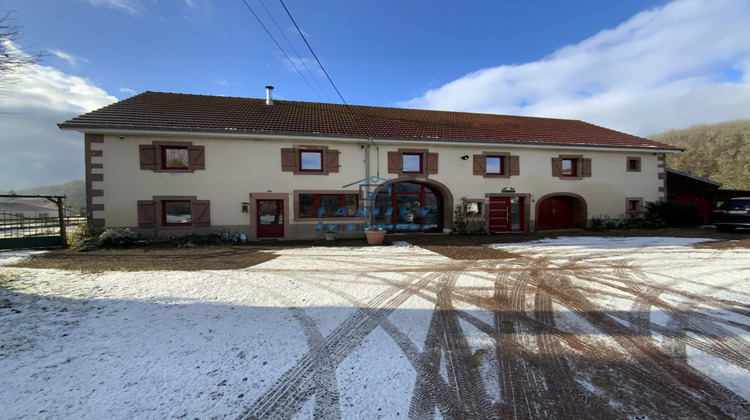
0;0;750;190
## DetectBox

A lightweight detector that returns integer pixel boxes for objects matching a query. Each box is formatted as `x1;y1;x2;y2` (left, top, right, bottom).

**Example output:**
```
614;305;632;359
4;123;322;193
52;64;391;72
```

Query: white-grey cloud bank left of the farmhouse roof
0;44;117;190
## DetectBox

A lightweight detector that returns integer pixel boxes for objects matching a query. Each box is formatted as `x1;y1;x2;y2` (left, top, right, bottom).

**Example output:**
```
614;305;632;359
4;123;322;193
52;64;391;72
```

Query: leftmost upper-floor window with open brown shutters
138;141;206;172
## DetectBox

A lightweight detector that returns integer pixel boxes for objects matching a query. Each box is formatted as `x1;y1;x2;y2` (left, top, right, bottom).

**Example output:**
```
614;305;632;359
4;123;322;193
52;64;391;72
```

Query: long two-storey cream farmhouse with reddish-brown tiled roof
59;87;680;240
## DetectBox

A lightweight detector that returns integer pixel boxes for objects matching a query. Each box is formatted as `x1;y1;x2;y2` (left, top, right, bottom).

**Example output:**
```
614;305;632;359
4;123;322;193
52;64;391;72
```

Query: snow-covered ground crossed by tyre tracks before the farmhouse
0;237;750;419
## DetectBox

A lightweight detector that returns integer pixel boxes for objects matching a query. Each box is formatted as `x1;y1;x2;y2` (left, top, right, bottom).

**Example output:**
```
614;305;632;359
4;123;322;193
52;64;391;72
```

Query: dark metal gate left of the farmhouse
0;195;70;249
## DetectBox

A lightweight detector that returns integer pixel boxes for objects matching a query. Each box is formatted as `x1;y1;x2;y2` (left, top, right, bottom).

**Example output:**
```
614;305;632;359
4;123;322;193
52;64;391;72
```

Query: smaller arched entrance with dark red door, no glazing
536;193;586;230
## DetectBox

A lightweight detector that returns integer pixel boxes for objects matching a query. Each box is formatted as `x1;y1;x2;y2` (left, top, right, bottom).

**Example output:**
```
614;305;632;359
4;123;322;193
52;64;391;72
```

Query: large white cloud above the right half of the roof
399;0;750;135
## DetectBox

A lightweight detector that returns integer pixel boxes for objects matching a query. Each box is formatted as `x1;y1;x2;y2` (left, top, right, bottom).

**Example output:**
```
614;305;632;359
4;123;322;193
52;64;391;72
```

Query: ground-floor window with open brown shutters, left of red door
138;196;211;229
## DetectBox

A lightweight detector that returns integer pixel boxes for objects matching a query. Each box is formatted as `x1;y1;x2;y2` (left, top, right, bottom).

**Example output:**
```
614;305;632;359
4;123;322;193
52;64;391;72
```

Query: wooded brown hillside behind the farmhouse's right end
648;120;750;190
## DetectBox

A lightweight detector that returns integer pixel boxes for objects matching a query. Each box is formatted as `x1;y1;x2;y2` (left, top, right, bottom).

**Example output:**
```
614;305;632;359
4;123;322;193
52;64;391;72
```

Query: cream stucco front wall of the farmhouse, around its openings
91;133;664;237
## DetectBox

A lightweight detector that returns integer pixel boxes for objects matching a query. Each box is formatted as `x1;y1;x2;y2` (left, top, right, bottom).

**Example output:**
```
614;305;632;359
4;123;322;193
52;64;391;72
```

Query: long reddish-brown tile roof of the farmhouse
59;92;679;150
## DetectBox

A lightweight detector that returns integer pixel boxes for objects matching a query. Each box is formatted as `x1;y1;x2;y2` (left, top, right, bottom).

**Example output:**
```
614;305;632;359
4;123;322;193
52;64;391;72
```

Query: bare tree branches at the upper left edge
0;11;42;89
